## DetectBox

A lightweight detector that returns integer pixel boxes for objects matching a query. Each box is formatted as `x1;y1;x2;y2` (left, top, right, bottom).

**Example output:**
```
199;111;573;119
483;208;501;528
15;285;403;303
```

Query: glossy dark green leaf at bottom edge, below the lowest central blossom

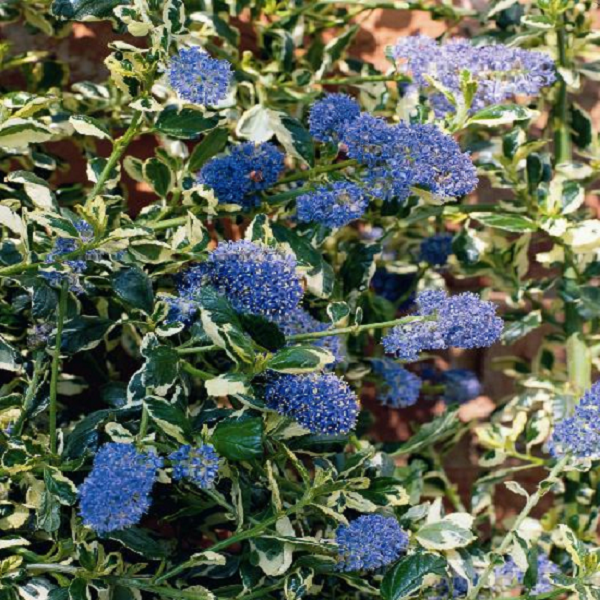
381;553;446;600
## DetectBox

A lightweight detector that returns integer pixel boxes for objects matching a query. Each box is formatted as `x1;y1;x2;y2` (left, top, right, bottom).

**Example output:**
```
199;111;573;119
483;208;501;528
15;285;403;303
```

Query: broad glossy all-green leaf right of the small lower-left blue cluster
210;417;264;460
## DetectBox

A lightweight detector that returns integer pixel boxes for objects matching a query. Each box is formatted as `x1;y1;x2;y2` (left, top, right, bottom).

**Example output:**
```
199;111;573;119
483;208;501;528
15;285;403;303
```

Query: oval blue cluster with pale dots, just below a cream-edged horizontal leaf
265;373;358;435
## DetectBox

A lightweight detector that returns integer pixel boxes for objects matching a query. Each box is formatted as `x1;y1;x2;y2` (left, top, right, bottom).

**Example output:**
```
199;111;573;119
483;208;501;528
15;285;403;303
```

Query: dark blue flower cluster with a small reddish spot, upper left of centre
198;142;284;208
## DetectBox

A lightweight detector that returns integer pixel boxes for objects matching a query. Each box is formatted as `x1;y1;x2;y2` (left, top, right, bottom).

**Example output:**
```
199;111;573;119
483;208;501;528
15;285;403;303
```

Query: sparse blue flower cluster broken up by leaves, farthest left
41;219;102;294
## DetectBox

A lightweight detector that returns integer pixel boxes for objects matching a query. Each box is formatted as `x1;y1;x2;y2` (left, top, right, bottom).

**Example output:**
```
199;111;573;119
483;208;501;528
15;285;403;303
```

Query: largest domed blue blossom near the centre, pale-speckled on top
199;240;304;321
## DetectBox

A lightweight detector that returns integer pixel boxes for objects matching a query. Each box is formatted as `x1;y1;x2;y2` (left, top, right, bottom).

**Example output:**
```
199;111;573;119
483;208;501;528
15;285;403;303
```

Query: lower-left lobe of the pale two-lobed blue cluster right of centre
381;321;446;362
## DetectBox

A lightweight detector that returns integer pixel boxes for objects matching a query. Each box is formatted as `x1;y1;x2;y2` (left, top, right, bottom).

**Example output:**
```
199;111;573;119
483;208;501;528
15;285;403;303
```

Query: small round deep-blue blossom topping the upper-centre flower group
308;94;360;143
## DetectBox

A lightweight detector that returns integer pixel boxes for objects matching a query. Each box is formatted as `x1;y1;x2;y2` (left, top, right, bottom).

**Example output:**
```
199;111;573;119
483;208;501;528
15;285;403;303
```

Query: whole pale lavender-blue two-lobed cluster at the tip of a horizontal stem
383;290;504;361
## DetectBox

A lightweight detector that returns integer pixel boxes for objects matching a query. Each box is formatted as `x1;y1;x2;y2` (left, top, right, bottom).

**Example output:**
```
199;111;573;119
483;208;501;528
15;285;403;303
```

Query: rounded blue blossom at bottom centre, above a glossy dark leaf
335;514;408;571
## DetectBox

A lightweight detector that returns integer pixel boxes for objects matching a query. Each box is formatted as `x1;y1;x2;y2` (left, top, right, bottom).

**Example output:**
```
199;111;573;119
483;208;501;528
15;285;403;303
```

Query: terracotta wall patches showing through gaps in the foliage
0;0;600;517
